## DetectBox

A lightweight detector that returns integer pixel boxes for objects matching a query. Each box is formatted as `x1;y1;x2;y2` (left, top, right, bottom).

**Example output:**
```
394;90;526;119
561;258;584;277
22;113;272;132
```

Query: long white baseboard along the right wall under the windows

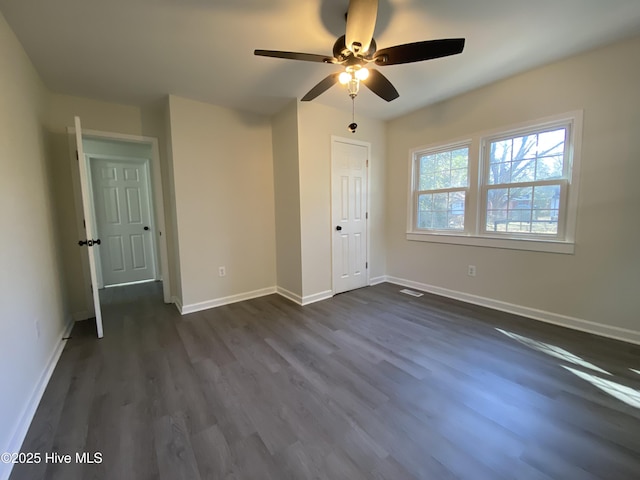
384;276;640;345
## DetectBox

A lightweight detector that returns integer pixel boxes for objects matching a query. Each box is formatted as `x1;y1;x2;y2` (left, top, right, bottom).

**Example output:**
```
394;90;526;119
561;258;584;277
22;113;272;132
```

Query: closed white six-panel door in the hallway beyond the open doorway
90;158;156;286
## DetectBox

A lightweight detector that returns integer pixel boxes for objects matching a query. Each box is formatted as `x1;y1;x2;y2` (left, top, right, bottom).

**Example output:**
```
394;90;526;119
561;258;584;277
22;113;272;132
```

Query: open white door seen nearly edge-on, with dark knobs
75;117;103;338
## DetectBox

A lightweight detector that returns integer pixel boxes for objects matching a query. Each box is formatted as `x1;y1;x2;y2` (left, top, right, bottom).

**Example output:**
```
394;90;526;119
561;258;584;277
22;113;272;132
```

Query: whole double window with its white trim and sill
407;112;582;253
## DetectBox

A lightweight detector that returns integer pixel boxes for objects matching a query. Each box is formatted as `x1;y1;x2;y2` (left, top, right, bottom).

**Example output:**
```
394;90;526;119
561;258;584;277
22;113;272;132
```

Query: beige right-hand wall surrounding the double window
387;37;640;336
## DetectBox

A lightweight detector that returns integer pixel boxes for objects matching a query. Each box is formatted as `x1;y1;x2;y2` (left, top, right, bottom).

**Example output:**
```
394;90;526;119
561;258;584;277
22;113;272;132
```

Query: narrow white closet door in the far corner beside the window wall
331;138;369;294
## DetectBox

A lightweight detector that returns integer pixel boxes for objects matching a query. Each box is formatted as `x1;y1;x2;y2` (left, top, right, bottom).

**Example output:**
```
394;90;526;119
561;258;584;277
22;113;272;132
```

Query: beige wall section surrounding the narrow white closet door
298;100;386;297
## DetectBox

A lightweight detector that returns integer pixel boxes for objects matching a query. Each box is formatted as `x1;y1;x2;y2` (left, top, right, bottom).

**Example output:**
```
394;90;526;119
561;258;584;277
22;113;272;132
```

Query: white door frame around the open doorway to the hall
67;127;172;304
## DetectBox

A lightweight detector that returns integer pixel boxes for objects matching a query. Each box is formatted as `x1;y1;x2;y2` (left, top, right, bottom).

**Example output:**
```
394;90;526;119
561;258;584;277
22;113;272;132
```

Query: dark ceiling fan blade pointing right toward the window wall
373;38;464;66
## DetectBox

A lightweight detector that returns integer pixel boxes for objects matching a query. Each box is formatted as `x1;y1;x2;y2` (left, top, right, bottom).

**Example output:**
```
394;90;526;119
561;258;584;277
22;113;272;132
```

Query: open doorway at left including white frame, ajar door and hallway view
69;122;171;337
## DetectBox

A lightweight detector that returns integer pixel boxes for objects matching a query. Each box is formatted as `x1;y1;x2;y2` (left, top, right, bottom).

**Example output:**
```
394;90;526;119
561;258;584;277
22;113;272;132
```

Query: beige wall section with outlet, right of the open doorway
169;95;276;307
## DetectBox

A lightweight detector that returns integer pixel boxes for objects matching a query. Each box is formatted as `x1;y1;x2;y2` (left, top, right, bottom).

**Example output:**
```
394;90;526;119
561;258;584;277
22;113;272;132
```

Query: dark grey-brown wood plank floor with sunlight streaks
11;284;640;480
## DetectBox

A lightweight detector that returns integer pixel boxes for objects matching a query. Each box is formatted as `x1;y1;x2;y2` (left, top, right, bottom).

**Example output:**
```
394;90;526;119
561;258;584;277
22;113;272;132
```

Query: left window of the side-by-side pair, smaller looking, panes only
414;146;469;231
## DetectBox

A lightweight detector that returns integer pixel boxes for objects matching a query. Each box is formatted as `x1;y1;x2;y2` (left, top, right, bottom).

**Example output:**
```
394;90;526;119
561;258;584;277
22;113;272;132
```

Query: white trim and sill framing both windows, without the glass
406;110;583;254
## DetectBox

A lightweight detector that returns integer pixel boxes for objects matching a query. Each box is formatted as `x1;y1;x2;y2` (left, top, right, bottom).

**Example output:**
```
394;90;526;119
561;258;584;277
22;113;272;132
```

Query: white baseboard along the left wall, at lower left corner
0;318;75;480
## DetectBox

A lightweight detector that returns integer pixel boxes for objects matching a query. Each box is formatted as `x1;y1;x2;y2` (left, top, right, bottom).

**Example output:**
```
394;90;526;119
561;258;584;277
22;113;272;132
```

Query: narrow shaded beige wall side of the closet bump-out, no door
271;100;302;298
